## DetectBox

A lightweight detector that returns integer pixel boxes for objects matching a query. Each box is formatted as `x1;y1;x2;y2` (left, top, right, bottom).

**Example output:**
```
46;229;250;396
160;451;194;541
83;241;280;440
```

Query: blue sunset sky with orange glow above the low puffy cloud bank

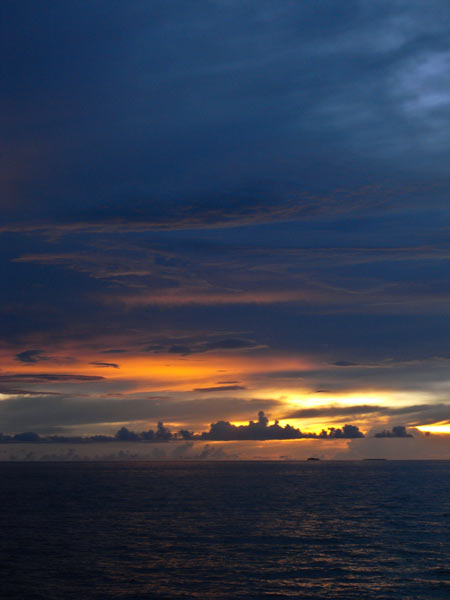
0;0;450;456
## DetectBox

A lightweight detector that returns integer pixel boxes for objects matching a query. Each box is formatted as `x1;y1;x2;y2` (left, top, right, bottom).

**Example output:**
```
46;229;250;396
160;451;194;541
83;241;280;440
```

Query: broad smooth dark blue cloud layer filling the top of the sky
2;0;449;233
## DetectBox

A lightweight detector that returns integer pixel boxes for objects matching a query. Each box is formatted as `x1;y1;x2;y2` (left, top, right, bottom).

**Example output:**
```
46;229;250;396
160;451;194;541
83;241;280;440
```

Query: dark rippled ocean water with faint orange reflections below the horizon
0;462;450;600
